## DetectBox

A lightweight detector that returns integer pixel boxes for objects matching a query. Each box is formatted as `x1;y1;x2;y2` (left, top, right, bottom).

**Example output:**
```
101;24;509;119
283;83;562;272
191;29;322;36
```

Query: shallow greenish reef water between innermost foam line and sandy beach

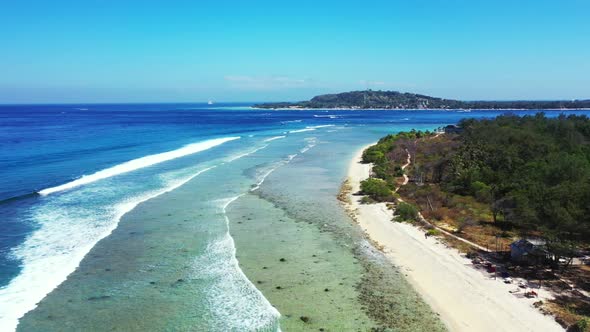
228;136;446;332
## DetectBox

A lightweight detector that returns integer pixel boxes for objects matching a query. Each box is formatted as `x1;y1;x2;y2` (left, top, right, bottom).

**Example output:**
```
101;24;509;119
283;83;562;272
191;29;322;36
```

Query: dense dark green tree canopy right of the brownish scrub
448;114;590;256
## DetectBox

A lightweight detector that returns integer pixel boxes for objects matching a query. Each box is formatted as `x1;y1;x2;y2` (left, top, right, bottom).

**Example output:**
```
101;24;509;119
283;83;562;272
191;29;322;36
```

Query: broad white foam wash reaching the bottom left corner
0;166;217;331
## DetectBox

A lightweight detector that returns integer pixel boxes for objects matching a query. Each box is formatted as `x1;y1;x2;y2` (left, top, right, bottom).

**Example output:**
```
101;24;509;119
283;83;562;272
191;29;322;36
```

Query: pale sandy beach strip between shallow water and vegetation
348;147;564;332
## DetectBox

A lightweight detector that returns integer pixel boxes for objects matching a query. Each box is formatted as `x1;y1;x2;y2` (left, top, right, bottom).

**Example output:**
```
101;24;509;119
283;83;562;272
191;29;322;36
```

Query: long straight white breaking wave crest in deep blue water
39;137;240;195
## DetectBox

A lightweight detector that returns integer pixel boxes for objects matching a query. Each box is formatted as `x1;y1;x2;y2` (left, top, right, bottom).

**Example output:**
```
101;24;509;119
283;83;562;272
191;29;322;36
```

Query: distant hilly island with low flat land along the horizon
253;90;590;110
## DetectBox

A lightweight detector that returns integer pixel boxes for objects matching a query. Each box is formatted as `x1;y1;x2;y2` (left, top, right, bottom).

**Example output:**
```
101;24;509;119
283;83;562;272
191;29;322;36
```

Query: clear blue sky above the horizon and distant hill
0;0;590;103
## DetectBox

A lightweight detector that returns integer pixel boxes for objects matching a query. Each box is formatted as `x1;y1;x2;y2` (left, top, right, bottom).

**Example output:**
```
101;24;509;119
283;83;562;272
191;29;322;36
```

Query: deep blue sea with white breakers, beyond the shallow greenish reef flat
0;104;590;330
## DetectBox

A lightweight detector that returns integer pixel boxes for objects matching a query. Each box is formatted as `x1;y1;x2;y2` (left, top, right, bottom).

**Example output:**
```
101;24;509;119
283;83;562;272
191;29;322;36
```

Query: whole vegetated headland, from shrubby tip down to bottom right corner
363;113;590;331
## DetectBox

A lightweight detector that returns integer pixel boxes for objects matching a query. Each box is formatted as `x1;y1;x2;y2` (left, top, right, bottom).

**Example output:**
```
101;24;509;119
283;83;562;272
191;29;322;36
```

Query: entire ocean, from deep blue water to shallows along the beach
0;104;590;331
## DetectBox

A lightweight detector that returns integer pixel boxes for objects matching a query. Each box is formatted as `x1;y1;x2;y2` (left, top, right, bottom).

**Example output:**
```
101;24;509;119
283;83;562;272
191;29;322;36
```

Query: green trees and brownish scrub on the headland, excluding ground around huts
363;113;590;258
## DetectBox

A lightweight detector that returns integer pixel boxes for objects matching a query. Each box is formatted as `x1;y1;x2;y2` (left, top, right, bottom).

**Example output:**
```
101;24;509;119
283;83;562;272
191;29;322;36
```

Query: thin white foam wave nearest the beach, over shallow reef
193;198;281;331
